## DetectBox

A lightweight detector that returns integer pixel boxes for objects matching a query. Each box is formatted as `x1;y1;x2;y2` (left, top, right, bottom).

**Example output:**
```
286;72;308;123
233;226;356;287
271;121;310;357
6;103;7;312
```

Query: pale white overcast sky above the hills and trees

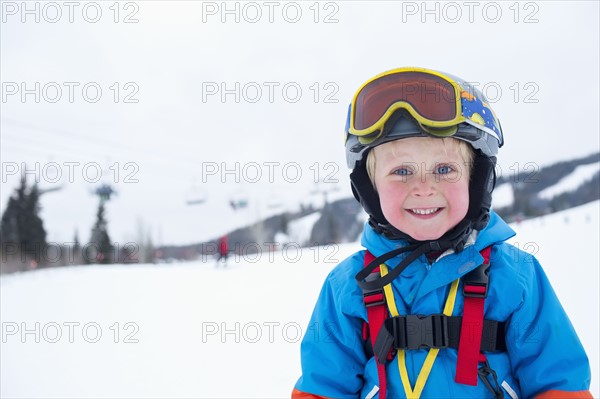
0;1;600;244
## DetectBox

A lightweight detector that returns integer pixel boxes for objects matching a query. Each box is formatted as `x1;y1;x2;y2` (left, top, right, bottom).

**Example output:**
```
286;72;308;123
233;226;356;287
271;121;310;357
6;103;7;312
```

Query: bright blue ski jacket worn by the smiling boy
292;212;592;399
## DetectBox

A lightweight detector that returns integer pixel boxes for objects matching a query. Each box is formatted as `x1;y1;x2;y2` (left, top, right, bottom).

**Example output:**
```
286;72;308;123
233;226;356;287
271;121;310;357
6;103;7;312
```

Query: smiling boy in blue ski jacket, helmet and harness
292;68;592;399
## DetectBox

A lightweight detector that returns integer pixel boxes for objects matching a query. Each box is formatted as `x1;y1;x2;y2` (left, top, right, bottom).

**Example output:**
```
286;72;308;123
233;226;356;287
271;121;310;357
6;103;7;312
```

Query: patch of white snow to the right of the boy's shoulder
511;201;600;398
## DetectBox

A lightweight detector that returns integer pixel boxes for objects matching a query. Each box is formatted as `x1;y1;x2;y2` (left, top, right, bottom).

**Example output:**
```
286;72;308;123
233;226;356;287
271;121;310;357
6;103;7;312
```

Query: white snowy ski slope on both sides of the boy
0;202;600;398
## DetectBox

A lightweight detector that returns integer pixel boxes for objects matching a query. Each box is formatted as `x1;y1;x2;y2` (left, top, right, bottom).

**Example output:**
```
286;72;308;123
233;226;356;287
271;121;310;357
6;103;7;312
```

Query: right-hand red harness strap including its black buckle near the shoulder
454;247;491;386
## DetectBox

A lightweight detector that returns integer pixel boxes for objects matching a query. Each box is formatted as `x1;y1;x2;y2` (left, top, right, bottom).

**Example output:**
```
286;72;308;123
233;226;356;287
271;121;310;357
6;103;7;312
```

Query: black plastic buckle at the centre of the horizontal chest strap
386;314;448;350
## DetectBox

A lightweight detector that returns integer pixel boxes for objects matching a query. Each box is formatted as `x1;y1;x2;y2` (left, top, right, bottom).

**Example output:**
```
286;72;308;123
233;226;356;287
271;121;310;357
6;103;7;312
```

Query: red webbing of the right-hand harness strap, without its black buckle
454;247;491;386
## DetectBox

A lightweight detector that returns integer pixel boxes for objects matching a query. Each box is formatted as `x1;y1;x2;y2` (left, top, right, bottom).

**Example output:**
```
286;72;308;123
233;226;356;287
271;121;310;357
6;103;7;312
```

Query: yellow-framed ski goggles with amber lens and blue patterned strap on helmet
347;68;503;145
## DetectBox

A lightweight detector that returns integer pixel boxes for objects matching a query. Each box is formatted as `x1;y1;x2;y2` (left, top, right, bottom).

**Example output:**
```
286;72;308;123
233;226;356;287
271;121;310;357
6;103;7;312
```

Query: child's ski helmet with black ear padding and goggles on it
345;68;504;251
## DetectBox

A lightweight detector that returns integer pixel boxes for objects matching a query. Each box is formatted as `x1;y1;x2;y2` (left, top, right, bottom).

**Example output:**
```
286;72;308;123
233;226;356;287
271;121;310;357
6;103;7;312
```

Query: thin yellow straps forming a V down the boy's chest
379;264;458;399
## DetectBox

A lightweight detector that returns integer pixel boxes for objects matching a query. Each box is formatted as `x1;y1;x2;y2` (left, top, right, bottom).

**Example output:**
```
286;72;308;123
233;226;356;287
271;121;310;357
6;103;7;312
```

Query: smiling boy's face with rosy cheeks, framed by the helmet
373;137;470;241
